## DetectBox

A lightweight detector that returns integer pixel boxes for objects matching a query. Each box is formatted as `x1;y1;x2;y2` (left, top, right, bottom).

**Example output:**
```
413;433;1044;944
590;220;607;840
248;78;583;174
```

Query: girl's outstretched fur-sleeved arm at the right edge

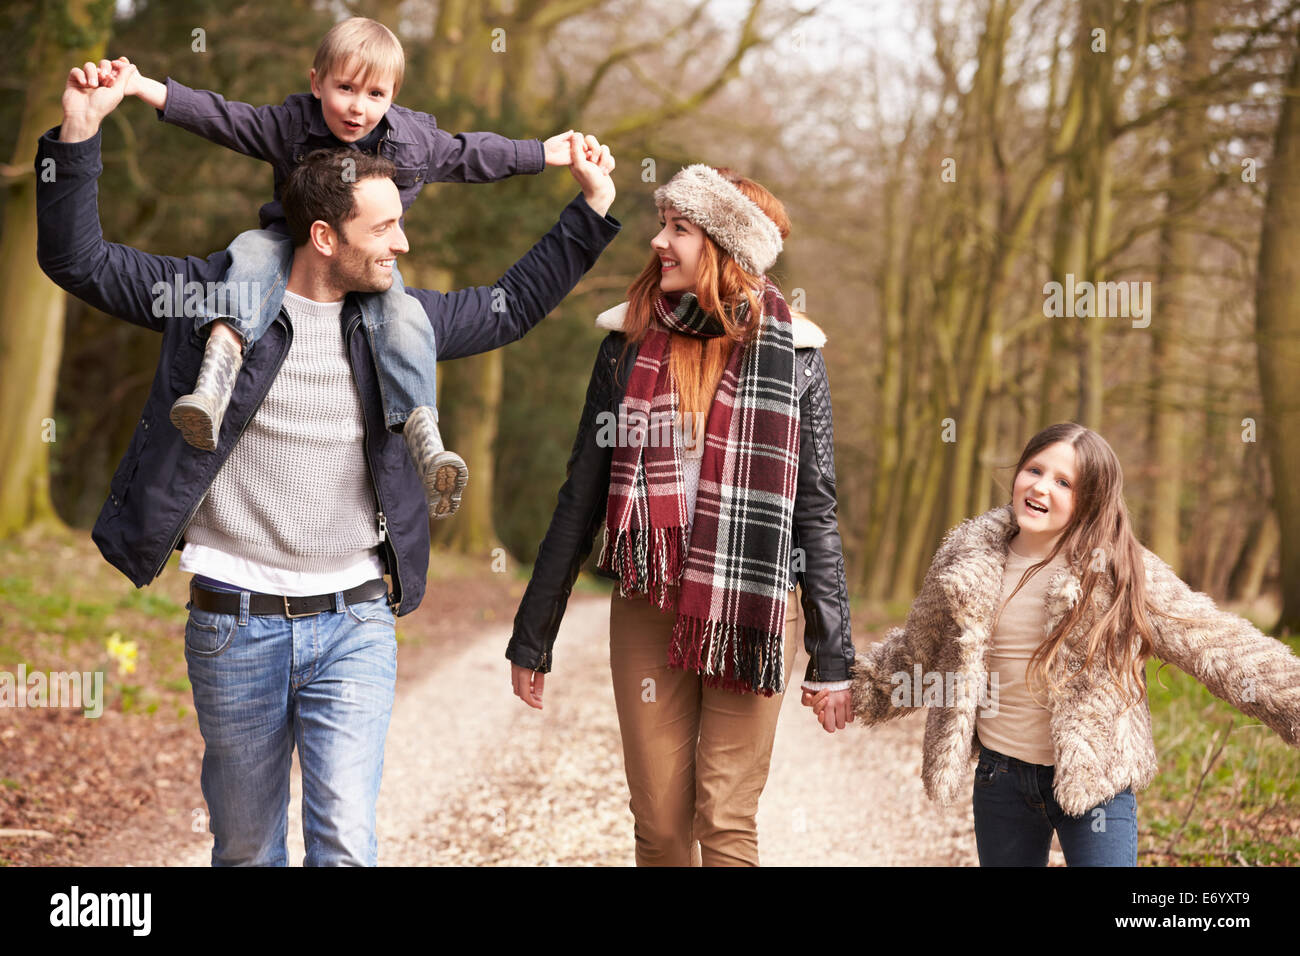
1143;549;1300;747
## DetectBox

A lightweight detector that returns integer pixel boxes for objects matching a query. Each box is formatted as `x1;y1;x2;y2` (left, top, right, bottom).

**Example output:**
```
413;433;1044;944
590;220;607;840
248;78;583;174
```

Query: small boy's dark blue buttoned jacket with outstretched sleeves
157;77;546;229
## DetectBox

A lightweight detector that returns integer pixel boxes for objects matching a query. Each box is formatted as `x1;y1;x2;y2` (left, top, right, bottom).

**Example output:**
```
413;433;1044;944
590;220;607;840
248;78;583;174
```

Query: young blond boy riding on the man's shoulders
126;17;585;518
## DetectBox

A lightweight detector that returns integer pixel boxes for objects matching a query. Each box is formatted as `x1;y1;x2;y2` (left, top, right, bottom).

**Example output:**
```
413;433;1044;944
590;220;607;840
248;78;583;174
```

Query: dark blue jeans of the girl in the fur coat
974;747;1138;866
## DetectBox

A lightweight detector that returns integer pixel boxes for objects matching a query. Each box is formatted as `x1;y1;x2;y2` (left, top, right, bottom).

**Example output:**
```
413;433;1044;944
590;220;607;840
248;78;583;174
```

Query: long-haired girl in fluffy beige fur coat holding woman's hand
805;423;1300;866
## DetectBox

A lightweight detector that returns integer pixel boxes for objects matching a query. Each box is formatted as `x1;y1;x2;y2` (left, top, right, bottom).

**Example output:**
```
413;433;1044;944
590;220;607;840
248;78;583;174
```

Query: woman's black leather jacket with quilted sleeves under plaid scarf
506;332;853;682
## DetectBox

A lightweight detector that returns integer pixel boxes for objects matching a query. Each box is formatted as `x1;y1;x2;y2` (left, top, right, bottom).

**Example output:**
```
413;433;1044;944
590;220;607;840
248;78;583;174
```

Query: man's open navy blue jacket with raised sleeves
36;127;620;615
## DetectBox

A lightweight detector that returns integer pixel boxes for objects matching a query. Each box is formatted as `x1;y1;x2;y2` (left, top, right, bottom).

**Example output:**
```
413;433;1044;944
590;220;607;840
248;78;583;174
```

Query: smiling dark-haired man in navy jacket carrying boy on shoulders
36;60;619;865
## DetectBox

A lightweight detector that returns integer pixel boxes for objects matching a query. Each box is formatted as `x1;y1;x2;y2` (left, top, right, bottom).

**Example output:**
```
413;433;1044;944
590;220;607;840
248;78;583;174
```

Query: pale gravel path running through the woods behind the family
167;598;976;866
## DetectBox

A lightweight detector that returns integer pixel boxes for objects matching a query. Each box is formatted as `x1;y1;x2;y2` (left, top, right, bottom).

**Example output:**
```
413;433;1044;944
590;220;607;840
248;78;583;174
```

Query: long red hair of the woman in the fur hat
619;166;790;412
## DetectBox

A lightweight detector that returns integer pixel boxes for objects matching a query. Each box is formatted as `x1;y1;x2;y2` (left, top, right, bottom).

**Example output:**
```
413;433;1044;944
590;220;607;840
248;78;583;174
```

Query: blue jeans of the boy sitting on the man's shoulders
194;229;438;429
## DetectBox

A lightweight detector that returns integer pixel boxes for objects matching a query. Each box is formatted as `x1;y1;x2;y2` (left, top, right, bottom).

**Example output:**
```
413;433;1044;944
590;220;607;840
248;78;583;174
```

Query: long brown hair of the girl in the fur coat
995;421;1153;706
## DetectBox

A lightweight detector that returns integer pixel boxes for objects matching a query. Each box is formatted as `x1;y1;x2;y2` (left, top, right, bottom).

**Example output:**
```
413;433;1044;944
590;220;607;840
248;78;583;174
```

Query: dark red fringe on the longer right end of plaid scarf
668;614;785;697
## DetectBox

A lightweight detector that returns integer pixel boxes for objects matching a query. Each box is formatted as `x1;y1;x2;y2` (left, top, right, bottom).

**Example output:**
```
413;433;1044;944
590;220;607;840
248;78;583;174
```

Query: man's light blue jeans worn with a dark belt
185;591;397;866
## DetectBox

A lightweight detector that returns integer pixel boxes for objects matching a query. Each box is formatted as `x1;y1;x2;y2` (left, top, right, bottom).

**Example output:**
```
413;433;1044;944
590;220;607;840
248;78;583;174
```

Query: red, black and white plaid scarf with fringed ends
598;282;800;696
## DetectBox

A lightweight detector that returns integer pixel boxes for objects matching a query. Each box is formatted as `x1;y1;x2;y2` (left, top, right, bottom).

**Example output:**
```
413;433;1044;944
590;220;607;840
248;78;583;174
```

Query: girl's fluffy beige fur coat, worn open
853;505;1300;817
